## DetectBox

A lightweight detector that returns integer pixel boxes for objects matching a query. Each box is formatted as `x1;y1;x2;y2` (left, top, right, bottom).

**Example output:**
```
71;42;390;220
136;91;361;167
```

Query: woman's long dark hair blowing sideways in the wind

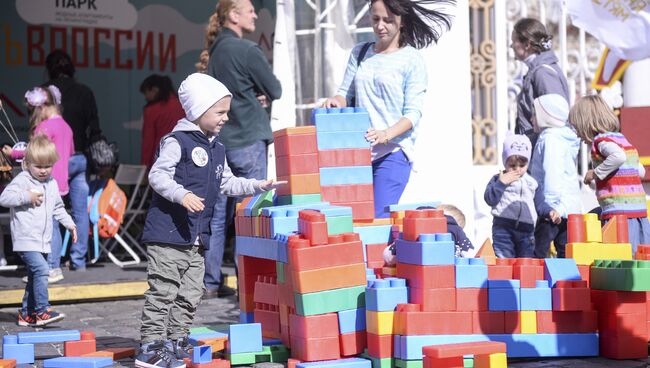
370;0;456;49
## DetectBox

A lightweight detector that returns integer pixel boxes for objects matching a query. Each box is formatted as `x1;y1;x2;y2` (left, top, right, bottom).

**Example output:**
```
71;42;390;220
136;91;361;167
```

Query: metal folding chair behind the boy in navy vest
101;164;149;267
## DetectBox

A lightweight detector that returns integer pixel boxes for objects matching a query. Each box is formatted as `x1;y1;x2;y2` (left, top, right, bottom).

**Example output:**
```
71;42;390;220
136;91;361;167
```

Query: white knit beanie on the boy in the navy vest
178;73;232;121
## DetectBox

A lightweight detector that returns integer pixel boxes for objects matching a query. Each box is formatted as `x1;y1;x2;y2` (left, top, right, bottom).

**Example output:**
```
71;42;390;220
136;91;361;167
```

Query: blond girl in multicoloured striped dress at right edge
569;95;650;252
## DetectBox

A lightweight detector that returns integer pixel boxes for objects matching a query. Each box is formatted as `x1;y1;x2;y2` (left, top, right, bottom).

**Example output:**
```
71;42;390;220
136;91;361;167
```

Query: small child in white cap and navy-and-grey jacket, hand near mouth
484;133;551;258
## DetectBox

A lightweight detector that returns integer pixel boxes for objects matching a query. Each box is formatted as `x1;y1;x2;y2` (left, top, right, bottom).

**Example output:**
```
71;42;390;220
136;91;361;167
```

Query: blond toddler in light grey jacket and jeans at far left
0;135;77;326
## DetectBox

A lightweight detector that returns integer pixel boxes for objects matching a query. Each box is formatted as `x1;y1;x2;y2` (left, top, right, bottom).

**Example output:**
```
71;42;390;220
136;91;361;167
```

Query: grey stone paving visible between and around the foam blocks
0;298;650;368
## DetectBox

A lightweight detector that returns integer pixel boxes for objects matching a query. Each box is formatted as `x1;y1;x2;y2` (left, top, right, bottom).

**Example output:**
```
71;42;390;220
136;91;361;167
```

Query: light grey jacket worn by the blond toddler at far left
0;171;74;253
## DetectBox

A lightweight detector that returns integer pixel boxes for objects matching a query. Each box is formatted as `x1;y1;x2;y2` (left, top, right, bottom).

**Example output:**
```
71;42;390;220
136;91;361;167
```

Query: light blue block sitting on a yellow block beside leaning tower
366;277;408;312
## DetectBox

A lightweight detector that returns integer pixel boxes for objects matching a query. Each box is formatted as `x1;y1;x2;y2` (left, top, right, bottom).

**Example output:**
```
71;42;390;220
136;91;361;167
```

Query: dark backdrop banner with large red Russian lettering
0;0;275;163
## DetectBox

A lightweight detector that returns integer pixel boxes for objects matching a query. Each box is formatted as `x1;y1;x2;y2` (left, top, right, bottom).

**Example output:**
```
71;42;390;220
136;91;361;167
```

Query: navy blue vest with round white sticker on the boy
142;131;226;249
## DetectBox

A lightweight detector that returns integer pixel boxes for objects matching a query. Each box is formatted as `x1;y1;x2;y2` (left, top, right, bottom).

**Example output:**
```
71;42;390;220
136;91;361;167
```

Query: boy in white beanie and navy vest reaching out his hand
135;73;282;368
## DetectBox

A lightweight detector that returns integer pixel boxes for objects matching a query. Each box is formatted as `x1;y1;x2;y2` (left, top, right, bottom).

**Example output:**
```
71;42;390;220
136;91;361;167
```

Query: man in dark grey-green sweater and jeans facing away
204;0;282;297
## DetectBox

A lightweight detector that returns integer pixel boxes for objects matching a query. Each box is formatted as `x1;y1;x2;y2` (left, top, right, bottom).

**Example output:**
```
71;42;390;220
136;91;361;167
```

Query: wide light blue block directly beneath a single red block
395;234;456;266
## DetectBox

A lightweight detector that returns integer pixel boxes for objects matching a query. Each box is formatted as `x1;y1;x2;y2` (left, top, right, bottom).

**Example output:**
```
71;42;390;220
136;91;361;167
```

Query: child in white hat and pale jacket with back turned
530;94;582;258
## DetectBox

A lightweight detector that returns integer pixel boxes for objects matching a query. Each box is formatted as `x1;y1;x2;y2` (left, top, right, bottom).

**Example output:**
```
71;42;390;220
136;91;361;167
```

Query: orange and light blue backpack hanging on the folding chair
88;179;127;238
